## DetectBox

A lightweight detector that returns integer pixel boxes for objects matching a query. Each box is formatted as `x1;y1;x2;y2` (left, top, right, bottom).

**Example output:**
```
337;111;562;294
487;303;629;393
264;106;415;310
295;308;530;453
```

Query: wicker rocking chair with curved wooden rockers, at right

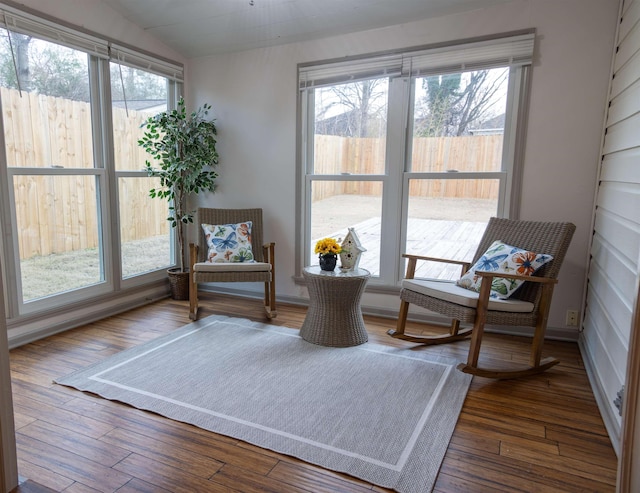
388;218;575;378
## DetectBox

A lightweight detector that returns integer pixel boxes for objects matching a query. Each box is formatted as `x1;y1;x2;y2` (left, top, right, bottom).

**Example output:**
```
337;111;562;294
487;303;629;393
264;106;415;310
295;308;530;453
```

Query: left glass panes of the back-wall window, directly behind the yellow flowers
308;78;389;271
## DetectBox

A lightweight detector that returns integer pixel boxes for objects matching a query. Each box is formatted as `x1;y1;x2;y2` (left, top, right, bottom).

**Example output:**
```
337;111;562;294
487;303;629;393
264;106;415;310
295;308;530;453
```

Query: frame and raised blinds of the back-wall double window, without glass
295;30;535;293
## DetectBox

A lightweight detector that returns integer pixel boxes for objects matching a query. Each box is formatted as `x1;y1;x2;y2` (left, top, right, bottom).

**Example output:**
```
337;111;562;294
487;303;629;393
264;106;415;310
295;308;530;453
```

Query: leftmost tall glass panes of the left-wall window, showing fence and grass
0;34;105;303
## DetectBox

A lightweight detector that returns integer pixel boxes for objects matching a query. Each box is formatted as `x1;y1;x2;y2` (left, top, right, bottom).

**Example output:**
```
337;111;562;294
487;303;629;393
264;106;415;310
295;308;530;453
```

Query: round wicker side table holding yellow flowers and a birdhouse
300;265;371;347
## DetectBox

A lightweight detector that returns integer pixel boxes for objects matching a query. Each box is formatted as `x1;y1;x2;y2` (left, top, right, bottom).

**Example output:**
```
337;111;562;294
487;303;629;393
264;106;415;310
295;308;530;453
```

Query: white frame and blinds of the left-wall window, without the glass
0;3;184;320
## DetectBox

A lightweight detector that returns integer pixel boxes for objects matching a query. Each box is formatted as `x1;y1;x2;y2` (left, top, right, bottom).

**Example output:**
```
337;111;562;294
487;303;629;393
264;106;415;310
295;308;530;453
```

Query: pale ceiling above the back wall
102;0;512;58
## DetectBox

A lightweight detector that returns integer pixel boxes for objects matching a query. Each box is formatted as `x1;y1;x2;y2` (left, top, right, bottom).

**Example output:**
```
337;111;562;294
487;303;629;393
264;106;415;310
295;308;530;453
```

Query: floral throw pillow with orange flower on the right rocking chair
456;241;553;300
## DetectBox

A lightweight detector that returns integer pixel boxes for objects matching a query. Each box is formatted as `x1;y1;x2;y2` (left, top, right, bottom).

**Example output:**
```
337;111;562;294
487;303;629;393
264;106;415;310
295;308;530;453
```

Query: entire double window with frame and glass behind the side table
297;33;534;286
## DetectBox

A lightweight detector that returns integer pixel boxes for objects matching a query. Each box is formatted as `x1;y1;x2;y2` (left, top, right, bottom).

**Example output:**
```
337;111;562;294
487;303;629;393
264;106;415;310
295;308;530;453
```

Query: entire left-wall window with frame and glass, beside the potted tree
0;7;181;317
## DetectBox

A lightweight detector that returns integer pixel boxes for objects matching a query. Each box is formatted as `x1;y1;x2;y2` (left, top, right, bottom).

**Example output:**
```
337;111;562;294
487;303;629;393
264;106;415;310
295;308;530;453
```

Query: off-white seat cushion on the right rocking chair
402;279;533;313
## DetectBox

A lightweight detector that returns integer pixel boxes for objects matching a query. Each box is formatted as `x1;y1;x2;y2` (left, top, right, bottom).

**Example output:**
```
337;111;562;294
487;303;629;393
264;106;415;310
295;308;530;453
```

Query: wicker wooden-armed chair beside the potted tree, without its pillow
189;208;277;320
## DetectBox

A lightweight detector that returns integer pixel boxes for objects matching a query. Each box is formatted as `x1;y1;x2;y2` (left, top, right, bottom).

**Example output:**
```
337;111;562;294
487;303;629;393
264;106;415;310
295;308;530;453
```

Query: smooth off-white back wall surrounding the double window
188;0;617;338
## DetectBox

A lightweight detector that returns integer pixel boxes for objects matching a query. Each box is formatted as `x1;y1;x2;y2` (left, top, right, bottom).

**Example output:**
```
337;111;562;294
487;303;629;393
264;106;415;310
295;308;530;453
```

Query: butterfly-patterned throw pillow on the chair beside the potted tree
202;221;255;263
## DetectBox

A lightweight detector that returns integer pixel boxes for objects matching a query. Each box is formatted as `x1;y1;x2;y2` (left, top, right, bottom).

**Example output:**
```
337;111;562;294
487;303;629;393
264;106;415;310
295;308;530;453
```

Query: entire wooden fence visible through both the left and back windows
5;88;502;258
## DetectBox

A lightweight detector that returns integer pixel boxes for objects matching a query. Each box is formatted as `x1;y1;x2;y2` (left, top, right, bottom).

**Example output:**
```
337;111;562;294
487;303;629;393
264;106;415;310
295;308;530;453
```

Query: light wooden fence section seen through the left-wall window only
0;88;169;259
